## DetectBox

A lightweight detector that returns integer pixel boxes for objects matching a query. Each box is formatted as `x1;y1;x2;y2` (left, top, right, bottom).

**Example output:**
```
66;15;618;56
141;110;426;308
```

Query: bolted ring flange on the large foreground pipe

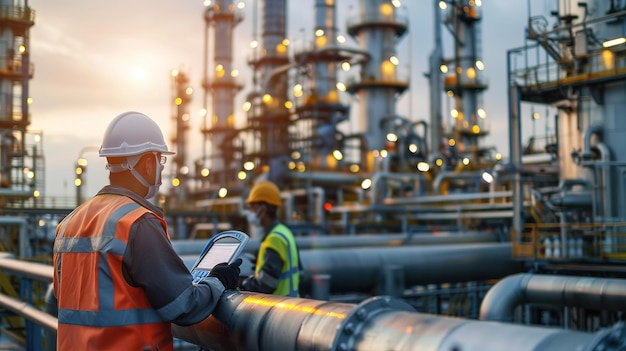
330;296;415;351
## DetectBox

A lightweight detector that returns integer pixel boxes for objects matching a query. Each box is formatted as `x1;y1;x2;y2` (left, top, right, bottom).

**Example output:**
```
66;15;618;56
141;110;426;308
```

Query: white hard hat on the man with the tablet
100;111;175;157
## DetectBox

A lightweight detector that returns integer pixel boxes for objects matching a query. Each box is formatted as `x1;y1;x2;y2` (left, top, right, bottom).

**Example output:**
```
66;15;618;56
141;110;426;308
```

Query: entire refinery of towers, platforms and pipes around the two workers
0;0;626;350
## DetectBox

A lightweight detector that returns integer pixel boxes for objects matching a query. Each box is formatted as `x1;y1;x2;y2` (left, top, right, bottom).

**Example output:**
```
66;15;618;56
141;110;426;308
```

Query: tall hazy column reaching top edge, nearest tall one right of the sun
202;0;243;184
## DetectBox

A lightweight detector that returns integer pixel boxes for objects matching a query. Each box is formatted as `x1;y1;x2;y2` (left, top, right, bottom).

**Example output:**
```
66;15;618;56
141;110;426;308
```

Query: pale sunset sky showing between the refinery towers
28;0;544;197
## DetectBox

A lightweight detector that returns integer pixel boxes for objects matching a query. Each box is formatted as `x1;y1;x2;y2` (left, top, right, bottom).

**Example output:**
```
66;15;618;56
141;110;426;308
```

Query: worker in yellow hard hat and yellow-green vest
240;181;300;297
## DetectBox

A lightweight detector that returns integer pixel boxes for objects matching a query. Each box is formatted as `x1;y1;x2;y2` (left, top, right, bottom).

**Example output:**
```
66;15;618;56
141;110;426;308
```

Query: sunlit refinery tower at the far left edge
0;0;44;201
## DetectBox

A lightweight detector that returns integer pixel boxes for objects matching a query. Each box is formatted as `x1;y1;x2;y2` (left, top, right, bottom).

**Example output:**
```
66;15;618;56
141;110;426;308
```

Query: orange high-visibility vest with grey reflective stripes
53;194;173;351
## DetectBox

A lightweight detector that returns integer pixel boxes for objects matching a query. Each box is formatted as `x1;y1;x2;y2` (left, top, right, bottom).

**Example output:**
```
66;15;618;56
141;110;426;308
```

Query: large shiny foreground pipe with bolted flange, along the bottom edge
172;291;626;351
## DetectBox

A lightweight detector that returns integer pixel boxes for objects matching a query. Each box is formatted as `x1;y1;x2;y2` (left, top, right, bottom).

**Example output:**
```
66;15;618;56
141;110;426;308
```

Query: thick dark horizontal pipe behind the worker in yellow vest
182;243;524;293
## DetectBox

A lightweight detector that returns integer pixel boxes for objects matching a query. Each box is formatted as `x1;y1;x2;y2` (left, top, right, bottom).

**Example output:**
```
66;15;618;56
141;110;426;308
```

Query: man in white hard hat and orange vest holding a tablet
53;112;241;351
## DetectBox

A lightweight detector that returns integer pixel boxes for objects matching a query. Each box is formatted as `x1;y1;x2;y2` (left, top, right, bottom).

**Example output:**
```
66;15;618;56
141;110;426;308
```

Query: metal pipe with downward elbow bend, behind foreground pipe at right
479;274;626;322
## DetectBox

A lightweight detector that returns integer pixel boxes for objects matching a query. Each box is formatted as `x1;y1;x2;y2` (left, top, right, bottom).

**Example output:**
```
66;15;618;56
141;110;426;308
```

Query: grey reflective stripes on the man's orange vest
54;195;163;327
